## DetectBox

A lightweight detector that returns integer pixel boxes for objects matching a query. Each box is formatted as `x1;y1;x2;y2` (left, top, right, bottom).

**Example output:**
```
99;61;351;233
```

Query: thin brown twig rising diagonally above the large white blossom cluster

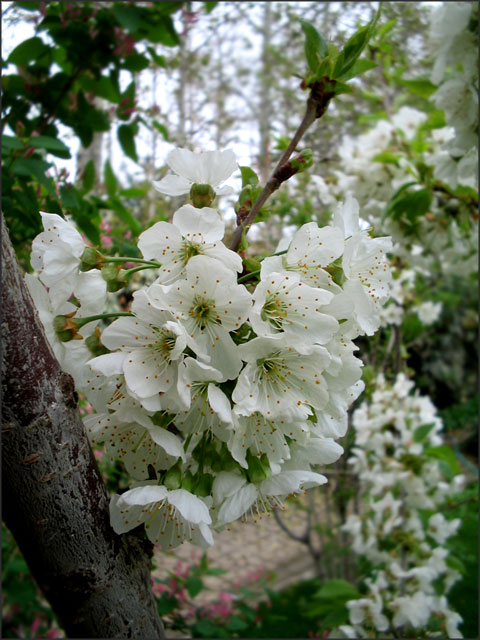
230;78;334;251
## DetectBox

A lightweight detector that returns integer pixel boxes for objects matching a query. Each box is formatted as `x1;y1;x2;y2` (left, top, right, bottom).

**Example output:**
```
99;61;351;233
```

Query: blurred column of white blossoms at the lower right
340;374;464;638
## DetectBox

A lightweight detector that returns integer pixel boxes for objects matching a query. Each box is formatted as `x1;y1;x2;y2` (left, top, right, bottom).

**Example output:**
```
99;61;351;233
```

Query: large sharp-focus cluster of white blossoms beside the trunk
28;149;391;549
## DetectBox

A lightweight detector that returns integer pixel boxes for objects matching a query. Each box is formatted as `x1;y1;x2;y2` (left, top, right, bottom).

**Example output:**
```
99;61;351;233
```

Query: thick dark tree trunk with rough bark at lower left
2;218;164;638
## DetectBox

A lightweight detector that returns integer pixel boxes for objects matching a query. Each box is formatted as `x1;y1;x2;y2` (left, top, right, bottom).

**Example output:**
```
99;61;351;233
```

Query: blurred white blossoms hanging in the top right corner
430;2;478;189
